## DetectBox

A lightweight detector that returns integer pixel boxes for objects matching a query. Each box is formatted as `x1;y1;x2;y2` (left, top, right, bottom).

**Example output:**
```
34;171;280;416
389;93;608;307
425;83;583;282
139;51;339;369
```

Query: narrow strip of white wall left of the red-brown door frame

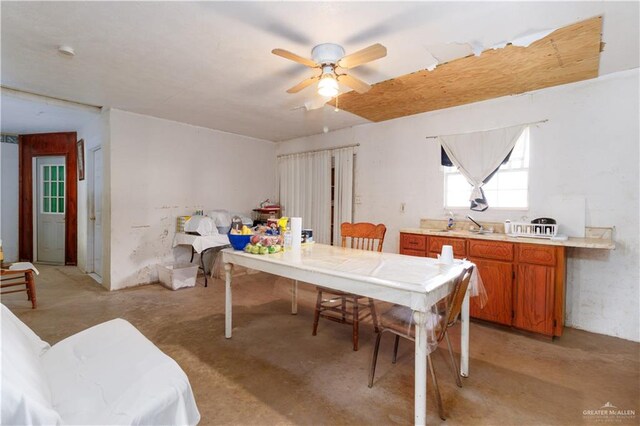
0;143;18;263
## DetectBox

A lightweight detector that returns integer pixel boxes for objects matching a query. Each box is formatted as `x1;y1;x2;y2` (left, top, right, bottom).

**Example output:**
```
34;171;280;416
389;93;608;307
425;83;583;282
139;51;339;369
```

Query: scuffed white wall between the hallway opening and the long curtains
108;109;276;290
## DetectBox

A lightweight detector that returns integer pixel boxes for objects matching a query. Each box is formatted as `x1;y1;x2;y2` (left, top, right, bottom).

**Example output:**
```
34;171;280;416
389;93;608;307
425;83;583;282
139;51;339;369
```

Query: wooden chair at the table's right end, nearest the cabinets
369;266;473;420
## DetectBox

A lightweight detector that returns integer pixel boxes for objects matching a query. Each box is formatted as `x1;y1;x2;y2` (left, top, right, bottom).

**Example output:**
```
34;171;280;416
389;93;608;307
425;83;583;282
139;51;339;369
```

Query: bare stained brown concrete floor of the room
2;266;640;425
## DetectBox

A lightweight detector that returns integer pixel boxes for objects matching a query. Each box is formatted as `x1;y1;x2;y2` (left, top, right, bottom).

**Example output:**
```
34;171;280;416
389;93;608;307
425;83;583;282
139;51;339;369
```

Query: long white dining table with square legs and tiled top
222;244;472;425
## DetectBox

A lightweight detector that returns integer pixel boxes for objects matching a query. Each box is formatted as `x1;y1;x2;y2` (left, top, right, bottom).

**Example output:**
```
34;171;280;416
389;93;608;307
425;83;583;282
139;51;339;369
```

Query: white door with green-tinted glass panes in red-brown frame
36;157;67;265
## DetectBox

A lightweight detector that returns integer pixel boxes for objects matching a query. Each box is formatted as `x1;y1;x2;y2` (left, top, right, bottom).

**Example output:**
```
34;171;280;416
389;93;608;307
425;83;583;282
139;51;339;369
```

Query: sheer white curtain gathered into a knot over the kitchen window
438;124;527;211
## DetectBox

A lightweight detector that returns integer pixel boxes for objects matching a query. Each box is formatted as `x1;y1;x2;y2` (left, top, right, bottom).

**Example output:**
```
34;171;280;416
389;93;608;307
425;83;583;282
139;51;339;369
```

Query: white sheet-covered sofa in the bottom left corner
0;305;200;425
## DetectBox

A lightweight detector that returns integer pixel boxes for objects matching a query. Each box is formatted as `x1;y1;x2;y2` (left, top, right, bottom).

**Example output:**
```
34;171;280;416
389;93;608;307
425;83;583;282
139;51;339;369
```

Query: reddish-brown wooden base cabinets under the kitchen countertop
400;233;565;336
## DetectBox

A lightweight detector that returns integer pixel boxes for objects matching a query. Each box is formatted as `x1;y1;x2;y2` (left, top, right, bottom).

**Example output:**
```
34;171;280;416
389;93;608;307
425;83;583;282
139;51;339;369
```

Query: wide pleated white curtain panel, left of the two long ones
278;151;331;244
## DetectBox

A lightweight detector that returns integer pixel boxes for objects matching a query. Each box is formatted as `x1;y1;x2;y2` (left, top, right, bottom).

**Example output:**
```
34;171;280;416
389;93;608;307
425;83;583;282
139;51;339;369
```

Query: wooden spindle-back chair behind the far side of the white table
312;222;387;351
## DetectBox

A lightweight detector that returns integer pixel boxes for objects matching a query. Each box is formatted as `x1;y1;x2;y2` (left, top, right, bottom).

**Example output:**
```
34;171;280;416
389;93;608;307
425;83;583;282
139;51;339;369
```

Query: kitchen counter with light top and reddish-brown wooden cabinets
399;219;615;337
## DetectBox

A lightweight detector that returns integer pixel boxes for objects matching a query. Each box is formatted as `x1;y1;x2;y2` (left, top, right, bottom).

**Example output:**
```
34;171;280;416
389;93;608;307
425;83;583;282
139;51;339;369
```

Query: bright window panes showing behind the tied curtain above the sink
444;128;529;209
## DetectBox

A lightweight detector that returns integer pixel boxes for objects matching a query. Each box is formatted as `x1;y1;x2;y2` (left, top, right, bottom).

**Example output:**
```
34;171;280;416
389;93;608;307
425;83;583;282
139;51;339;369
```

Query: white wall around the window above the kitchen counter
278;69;640;341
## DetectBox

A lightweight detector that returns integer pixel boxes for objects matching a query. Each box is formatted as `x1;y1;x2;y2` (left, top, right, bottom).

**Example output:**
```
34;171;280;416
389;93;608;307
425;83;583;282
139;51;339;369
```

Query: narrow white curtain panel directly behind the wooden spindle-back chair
333;147;354;246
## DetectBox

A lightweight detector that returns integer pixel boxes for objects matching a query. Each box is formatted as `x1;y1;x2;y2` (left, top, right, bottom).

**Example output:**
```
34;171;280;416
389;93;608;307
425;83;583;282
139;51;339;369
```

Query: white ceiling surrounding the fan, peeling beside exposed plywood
0;1;640;141
